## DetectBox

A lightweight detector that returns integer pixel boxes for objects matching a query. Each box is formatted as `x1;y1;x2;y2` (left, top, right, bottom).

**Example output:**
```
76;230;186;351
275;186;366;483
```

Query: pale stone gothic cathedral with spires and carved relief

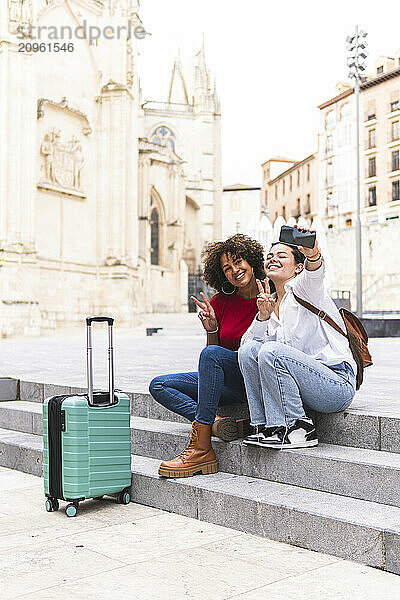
0;0;222;336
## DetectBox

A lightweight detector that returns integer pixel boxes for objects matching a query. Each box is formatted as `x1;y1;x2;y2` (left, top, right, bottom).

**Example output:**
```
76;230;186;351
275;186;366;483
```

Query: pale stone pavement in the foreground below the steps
0;468;400;600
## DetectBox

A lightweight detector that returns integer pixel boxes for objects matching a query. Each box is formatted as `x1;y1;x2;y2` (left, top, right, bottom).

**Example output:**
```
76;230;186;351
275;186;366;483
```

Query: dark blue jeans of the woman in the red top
149;346;246;425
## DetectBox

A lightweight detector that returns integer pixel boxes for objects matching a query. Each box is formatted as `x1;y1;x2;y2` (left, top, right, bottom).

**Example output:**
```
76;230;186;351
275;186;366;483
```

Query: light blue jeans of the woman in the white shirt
239;341;356;427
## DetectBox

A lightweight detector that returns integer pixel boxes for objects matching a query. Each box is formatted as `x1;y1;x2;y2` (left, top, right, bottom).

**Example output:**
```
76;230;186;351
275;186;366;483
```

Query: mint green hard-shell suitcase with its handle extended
43;317;131;517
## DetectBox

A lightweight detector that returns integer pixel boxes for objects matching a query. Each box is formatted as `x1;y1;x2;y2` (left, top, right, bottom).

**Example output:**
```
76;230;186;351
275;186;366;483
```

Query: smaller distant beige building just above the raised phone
261;154;318;225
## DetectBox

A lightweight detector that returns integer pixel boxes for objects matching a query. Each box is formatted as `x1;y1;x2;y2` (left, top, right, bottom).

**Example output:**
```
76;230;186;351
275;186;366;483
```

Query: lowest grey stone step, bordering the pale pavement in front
0;429;400;574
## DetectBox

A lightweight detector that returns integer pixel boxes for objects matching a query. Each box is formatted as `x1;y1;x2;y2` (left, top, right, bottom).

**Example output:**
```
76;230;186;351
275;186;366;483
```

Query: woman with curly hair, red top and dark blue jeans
150;233;265;477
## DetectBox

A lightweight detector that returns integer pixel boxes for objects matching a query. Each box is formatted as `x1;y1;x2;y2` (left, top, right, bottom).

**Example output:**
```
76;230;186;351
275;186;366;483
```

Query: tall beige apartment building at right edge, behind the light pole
318;51;400;310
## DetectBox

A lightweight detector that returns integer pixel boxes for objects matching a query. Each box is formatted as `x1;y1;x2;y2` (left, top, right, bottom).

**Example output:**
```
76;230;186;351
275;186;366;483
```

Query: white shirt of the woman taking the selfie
240;262;357;374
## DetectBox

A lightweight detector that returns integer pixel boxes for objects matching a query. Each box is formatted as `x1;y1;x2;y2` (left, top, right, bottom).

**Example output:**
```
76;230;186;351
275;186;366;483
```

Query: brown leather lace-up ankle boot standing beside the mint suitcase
158;421;218;477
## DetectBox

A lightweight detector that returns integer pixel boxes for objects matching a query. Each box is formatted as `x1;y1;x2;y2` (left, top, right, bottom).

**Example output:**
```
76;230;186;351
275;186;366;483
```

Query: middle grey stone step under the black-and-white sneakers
0;401;400;506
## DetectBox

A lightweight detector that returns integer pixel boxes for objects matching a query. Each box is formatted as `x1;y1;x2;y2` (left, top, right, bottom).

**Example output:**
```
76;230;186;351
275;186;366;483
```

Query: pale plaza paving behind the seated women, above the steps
0;313;400;416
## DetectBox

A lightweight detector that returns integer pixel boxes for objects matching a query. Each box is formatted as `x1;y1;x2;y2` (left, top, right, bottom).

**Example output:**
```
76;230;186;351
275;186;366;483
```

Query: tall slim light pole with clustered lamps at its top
346;25;368;317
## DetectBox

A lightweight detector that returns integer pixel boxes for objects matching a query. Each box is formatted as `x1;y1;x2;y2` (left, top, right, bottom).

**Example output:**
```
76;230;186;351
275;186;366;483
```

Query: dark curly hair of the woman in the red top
201;233;265;292
